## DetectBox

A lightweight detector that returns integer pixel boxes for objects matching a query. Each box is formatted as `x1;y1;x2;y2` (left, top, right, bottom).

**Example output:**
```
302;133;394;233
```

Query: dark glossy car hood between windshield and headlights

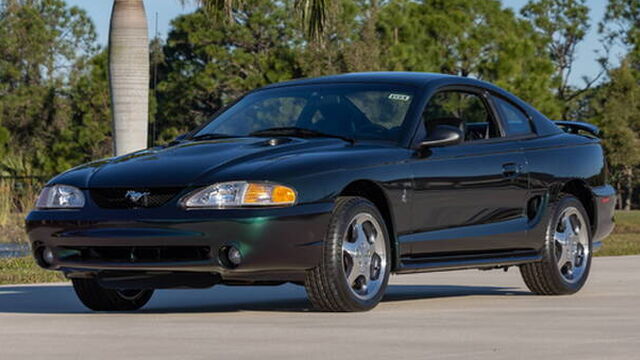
51;138;351;188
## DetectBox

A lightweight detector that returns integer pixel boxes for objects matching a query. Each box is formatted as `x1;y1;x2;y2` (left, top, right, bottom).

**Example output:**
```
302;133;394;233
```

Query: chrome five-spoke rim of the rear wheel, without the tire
553;207;590;283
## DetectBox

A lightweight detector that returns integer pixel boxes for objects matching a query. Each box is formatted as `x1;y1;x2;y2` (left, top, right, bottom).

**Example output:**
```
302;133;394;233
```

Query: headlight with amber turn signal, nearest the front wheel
182;181;297;209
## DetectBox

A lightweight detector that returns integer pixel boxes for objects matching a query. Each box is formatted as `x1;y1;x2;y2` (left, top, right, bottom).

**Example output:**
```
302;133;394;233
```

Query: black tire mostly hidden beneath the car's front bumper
72;279;153;311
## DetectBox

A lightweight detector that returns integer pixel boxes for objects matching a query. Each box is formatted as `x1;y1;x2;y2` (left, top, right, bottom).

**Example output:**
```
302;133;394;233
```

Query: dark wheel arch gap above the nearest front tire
339;180;398;271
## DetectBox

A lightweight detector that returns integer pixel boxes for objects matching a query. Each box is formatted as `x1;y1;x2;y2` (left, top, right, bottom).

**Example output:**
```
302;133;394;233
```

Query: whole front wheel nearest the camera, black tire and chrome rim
305;197;391;311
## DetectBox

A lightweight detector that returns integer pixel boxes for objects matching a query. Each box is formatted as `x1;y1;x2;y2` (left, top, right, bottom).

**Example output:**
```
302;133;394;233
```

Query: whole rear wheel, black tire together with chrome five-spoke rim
520;195;592;295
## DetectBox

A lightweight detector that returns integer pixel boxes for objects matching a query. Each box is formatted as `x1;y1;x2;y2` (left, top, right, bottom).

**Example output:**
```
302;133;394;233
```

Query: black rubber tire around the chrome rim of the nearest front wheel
305;197;391;312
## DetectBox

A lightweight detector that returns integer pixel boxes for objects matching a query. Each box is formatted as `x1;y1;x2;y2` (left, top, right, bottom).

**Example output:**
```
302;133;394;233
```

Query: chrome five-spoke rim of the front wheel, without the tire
342;213;387;300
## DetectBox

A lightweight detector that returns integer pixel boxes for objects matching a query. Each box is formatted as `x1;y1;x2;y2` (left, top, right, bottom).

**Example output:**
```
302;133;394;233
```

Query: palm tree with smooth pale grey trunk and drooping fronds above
109;0;327;155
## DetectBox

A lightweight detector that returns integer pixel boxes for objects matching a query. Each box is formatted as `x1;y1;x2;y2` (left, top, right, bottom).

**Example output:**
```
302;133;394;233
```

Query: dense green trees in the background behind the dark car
0;0;640;208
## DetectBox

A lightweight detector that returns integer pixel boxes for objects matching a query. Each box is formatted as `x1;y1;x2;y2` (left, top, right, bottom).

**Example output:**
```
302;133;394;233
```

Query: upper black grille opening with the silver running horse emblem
89;188;182;209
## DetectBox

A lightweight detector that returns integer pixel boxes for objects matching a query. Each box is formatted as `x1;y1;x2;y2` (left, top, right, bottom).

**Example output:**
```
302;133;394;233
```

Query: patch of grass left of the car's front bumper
0;257;65;285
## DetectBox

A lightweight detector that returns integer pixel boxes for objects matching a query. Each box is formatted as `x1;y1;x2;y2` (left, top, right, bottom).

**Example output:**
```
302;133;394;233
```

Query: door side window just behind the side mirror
423;91;500;141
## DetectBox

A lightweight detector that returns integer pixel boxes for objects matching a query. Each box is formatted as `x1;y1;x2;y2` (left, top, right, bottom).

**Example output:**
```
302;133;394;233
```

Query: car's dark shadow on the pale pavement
0;284;530;314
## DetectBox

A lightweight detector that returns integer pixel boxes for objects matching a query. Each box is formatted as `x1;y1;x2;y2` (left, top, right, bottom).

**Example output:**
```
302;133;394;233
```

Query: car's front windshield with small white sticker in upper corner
192;84;414;141
